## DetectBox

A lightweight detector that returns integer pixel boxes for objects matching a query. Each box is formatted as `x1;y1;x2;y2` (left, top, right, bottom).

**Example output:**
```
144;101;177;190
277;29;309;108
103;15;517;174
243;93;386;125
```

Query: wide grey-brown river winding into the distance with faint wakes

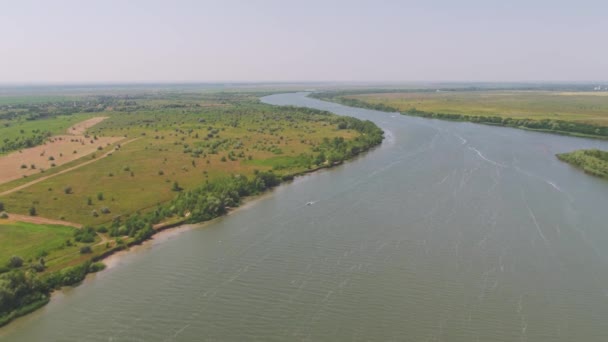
0;93;608;342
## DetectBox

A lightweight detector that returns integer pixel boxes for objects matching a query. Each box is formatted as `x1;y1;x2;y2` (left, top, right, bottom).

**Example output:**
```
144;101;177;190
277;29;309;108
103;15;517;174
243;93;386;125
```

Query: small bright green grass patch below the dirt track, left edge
0;222;79;265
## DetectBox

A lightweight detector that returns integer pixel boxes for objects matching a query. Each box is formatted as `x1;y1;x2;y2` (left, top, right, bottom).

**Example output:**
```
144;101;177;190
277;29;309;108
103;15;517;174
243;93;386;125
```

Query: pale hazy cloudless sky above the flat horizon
0;0;608;83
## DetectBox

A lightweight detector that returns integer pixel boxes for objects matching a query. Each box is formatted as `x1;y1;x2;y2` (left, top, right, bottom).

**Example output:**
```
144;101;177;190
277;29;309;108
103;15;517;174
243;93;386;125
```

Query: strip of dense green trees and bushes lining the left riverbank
0;98;384;324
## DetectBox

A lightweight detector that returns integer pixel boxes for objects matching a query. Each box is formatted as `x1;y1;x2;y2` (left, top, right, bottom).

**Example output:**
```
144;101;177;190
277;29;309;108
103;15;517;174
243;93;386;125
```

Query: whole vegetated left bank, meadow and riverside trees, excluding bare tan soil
0;89;383;325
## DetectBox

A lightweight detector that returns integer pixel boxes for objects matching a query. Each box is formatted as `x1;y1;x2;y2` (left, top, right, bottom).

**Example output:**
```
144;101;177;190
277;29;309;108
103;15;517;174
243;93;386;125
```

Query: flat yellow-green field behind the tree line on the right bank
345;91;608;126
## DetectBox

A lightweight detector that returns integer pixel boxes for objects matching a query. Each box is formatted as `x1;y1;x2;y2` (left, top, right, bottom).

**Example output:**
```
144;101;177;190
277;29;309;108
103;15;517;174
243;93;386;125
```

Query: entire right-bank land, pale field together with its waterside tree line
311;90;608;138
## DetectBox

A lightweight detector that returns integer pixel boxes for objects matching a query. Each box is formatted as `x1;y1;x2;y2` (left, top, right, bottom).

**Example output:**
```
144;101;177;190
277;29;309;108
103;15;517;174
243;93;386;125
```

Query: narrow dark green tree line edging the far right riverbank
310;92;608;138
